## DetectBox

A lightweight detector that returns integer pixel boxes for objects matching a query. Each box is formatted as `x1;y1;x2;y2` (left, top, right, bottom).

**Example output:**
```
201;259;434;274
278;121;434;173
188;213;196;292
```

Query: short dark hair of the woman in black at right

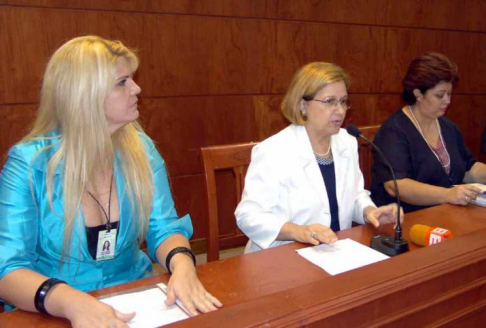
402;52;459;105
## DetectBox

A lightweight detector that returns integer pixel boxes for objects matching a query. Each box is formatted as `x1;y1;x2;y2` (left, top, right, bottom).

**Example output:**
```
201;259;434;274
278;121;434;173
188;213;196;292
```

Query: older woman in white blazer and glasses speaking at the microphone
235;62;403;253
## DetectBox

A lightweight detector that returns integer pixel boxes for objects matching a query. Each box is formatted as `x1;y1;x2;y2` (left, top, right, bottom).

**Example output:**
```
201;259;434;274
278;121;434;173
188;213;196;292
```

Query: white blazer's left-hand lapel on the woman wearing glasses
295;126;329;213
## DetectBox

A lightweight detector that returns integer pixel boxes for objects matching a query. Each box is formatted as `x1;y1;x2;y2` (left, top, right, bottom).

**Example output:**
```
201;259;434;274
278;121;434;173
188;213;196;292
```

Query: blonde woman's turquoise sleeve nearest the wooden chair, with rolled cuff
142;139;193;261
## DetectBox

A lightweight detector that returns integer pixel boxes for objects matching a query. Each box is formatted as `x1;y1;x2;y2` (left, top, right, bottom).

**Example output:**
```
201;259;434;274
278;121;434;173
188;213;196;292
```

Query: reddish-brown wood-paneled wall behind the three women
0;0;486;251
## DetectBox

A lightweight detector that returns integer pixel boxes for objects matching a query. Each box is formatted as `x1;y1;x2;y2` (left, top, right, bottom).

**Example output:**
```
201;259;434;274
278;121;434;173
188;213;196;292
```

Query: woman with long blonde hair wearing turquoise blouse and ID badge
0;36;221;327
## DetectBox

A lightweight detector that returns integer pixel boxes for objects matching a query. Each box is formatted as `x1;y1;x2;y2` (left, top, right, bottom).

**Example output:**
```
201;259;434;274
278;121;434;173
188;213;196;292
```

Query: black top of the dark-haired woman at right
371;109;476;213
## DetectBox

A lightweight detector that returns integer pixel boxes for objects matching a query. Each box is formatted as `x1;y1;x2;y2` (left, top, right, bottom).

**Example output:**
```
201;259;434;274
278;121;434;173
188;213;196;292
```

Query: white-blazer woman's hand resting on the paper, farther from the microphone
277;222;338;246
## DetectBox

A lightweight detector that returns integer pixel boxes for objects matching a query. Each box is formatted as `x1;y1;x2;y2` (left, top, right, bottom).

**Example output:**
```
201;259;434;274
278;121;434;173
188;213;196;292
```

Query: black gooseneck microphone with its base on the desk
346;124;409;256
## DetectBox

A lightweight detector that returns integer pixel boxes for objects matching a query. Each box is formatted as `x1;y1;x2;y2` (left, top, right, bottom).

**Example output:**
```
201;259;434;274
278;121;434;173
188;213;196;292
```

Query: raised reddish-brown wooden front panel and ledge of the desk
173;229;486;327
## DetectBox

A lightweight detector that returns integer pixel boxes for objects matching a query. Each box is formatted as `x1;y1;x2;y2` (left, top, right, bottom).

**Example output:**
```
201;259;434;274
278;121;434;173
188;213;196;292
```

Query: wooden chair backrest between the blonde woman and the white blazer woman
201;142;257;262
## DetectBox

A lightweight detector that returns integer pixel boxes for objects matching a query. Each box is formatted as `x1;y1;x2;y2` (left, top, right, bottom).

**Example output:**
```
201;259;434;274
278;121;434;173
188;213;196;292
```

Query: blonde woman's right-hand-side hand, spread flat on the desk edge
165;254;223;316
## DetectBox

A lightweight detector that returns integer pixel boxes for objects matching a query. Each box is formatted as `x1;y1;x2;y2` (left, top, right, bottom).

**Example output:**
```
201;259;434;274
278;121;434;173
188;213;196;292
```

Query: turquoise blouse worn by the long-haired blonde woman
0;132;192;291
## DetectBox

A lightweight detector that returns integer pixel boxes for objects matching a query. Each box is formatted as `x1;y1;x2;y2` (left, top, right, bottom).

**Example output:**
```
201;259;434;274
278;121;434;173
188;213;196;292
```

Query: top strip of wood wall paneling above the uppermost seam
0;0;486;32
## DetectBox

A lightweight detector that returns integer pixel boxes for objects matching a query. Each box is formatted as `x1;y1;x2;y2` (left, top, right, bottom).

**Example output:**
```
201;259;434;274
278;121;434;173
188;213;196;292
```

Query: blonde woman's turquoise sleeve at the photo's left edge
0;146;39;279
